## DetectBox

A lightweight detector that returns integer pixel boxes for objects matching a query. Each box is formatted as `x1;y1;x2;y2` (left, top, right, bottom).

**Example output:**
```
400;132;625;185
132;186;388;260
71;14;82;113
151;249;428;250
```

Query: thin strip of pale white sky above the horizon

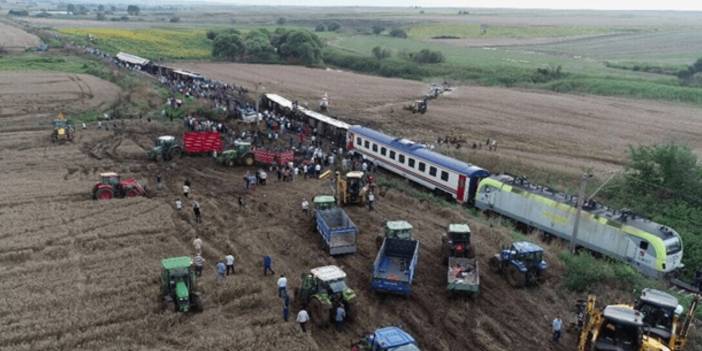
227;0;702;11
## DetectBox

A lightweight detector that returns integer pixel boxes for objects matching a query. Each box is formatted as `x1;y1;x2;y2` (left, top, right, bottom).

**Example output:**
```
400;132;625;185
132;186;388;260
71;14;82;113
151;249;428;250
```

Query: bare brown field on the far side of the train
180;63;702;177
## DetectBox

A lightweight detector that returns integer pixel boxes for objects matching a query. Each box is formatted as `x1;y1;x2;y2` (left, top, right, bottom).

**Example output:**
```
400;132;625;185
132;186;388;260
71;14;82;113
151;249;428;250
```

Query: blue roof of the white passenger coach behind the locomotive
349;125;490;177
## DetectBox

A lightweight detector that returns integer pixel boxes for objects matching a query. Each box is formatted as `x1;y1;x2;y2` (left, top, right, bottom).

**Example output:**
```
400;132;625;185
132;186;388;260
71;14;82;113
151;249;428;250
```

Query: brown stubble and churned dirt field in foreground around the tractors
0;70;600;351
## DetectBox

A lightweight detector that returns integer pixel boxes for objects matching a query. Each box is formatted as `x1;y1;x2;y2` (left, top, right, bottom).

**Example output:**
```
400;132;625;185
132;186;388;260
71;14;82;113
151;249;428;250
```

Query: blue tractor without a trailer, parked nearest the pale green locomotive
490;241;548;288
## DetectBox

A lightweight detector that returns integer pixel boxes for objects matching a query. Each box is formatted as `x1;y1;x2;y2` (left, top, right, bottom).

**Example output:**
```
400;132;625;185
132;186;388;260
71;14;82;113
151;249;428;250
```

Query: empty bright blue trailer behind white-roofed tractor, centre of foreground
371;238;419;296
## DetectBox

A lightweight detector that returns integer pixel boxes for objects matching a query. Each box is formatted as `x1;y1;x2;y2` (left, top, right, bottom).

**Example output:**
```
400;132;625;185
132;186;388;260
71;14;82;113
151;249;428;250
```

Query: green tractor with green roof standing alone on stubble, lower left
161;256;202;312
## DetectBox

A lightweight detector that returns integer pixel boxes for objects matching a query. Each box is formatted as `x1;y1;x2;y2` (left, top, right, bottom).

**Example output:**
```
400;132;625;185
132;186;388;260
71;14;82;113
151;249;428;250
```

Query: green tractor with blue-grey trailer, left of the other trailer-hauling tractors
313;195;358;256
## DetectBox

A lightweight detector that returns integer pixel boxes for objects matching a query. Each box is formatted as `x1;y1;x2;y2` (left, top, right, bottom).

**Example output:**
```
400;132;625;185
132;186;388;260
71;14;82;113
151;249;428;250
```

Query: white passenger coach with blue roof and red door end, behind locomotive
347;126;490;203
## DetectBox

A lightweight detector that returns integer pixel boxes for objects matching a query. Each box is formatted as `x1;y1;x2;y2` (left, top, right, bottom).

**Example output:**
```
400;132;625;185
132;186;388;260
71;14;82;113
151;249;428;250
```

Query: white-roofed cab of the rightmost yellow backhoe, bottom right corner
634;288;679;344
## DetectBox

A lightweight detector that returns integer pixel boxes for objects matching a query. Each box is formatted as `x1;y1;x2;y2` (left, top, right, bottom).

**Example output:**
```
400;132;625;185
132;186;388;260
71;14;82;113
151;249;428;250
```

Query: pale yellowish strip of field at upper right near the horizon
407;23;611;40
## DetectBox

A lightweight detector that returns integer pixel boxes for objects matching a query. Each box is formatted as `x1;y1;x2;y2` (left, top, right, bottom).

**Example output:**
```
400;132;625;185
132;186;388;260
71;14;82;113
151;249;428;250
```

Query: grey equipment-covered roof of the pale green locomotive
490;174;678;240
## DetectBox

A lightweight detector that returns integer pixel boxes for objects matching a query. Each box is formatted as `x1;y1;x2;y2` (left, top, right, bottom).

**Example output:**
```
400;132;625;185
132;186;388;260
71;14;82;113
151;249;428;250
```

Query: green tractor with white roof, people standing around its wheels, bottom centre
295;265;356;327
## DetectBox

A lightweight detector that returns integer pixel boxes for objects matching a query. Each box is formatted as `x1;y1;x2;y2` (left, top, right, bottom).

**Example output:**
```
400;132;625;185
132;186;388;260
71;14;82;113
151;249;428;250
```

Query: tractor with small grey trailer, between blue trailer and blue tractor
448;224;480;294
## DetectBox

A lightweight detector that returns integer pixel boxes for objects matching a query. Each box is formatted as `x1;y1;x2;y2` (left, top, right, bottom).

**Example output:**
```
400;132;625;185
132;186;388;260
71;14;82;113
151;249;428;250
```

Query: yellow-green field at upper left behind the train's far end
59;28;212;60
